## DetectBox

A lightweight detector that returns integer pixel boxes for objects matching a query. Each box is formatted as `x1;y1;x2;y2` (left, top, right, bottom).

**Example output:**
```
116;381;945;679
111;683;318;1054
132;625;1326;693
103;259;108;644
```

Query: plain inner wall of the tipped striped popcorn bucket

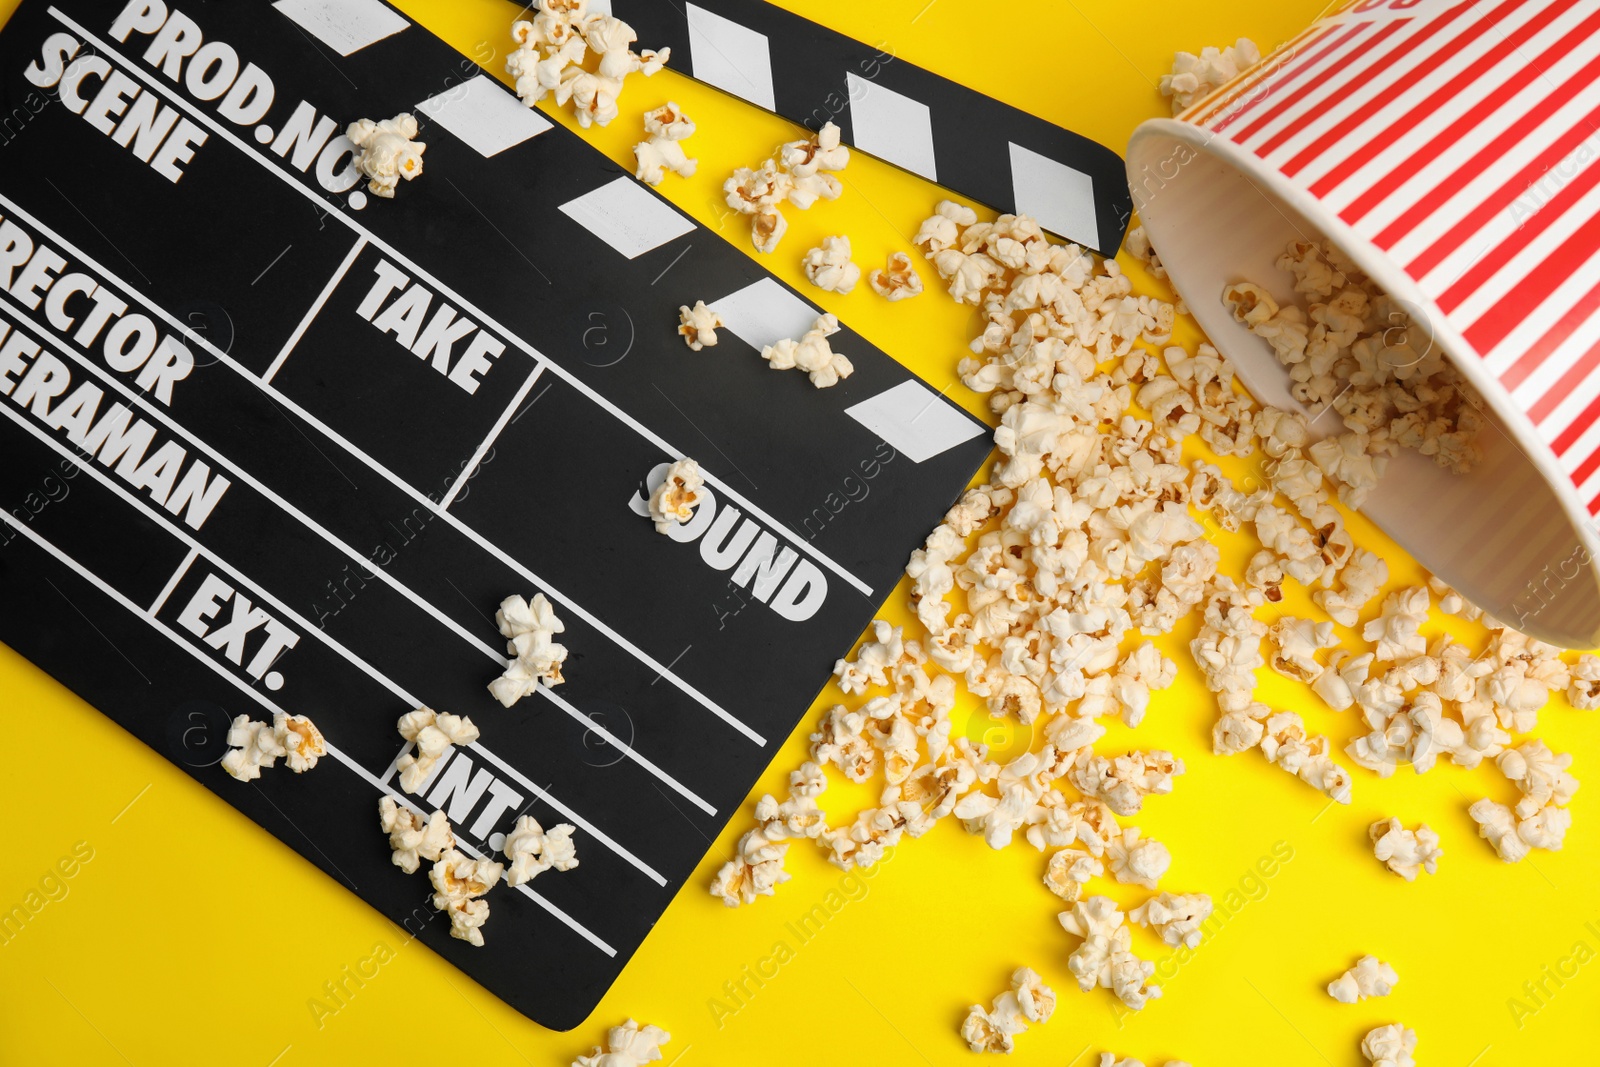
1128;126;1600;648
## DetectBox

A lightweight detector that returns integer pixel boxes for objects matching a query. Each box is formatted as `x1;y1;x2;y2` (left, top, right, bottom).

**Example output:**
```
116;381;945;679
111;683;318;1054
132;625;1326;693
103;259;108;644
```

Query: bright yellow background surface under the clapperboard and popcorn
0;0;1600;1067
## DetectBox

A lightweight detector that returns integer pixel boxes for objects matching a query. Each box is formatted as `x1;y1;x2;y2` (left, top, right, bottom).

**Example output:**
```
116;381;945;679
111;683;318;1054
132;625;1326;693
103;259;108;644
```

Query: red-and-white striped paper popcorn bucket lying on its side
1128;0;1600;648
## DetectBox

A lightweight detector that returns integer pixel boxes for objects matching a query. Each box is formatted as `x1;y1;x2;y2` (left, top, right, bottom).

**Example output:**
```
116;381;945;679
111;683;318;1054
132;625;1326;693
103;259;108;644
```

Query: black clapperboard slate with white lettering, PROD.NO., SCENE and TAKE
0;0;1062;1029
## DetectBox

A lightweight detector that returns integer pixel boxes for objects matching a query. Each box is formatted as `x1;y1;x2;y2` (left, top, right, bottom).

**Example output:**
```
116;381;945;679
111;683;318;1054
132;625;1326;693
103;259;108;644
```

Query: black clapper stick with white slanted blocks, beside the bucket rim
601;0;1133;258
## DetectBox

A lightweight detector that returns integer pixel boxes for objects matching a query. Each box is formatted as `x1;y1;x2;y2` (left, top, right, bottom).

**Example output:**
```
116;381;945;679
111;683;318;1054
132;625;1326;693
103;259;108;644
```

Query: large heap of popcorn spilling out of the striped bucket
712;187;1600;1064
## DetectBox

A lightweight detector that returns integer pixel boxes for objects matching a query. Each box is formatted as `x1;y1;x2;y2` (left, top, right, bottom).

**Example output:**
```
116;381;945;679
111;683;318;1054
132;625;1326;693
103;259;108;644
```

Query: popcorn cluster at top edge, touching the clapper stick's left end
506;0;665;127
